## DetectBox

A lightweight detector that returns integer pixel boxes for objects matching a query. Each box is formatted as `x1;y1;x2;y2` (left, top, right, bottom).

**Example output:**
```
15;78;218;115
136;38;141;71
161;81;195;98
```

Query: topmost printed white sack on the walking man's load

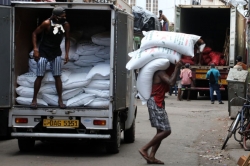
140;31;201;57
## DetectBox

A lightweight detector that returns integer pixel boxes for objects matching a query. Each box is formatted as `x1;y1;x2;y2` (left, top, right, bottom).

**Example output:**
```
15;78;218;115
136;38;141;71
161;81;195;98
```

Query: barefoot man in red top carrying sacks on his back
139;61;182;164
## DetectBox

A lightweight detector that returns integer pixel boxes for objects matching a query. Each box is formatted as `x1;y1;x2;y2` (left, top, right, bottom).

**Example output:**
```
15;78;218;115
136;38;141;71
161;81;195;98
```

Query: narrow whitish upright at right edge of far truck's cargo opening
229;8;237;67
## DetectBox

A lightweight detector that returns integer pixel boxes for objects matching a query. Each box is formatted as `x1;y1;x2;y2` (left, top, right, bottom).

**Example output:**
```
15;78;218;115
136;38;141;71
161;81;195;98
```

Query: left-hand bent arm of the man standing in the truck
32;20;50;61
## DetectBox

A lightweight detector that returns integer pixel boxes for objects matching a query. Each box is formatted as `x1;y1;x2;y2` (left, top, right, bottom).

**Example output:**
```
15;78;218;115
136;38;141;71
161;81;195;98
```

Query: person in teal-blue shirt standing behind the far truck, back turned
206;63;224;104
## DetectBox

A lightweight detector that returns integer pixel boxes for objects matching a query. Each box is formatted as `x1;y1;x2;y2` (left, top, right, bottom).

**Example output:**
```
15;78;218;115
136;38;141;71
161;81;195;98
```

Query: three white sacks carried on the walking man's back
126;31;200;104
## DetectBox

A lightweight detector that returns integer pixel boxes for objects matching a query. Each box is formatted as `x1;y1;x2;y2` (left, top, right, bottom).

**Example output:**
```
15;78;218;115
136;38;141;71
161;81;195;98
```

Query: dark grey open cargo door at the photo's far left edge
0;6;12;108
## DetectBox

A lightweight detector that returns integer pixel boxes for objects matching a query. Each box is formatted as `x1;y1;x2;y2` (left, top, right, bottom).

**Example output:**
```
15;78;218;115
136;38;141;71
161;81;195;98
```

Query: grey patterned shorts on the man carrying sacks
147;97;171;131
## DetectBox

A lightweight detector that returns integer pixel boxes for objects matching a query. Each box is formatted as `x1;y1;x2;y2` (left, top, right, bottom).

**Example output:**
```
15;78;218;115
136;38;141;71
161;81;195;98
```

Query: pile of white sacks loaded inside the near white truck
16;32;110;108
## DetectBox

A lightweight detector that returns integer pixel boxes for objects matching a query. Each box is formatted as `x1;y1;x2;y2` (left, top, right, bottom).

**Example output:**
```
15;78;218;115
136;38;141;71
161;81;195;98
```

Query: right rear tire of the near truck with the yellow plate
106;114;121;154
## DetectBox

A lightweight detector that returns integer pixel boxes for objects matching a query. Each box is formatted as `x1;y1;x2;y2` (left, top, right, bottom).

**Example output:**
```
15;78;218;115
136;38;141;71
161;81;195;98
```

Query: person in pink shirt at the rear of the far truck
180;63;194;101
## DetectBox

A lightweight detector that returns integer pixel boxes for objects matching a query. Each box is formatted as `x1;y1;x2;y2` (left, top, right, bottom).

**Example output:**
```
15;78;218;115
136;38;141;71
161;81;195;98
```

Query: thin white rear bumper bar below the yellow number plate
11;132;111;139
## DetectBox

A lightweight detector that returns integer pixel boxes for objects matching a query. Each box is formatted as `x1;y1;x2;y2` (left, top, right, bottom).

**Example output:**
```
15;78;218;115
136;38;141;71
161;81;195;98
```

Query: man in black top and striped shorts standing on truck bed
30;7;70;109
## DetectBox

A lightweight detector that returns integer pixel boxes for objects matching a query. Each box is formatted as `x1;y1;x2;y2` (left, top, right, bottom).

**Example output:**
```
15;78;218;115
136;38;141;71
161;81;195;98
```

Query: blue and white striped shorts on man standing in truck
36;56;62;76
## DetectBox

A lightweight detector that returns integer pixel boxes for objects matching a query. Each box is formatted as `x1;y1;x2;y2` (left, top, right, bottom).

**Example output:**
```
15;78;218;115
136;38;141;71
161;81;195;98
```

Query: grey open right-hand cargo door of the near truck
114;11;130;110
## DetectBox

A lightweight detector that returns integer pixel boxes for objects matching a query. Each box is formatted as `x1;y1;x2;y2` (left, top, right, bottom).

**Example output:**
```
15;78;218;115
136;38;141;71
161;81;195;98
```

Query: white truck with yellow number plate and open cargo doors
0;1;137;153
